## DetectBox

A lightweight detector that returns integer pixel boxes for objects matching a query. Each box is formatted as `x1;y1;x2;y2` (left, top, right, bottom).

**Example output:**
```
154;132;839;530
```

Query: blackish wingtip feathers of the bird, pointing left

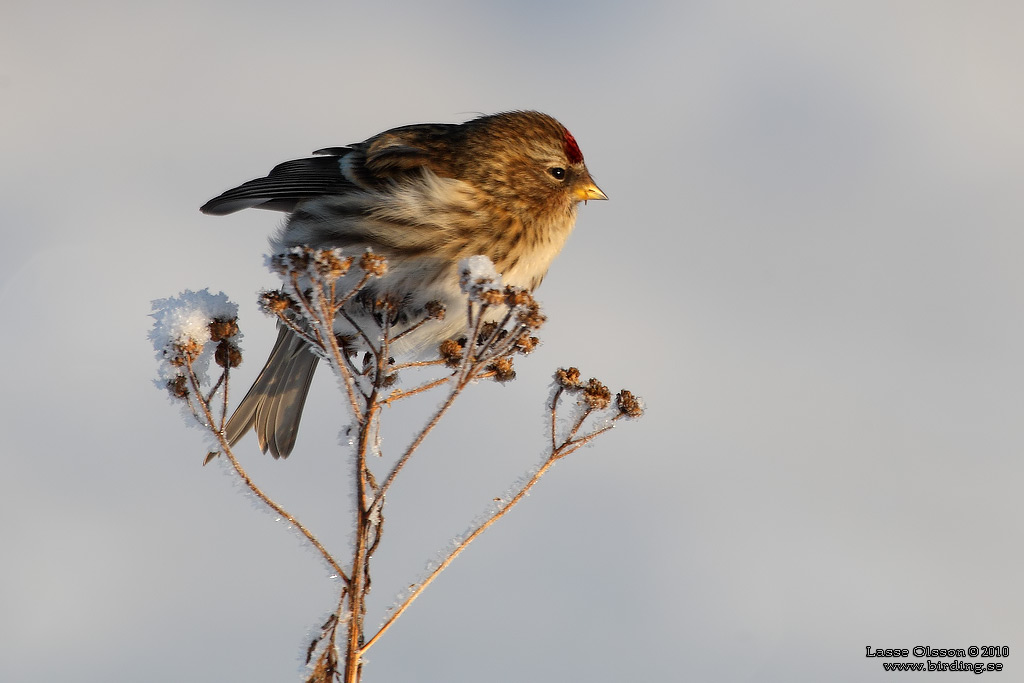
200;147;355;216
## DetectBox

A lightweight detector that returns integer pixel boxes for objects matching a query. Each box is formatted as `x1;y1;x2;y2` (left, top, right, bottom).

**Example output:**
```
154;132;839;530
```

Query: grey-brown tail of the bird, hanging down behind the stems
224;326;318;458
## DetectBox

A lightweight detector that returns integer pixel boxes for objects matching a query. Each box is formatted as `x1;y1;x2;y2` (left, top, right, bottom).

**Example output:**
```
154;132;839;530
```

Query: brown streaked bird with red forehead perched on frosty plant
200;111;607;459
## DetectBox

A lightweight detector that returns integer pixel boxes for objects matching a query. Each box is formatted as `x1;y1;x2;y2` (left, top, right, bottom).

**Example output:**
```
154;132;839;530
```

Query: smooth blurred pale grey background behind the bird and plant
0;0;1024;682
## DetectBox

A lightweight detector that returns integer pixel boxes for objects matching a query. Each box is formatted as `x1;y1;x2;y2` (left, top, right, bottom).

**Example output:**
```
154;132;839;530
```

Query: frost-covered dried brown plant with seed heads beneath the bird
151;247;643;683
